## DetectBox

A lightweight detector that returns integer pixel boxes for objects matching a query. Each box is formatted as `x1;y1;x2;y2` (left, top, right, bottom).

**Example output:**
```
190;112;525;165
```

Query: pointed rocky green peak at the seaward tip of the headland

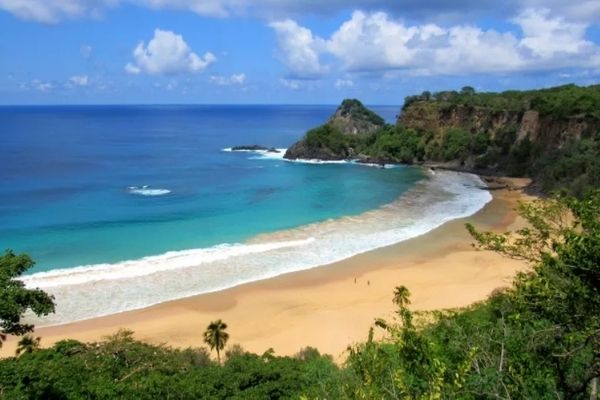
284;99;385;160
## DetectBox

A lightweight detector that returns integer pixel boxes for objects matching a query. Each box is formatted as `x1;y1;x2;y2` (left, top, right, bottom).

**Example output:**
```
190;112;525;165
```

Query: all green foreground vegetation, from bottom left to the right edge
0;191;600;399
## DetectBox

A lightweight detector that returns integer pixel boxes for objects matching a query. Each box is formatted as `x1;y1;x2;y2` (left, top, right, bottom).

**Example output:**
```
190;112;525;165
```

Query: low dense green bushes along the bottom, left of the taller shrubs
0;331;339;399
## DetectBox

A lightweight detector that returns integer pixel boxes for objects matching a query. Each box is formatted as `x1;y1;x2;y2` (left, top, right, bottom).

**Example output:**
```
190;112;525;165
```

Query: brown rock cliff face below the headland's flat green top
397;101;600;176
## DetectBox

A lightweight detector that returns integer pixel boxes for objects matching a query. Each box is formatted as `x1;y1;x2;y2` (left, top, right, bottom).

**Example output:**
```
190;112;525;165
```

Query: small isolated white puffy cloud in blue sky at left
125;29;217;74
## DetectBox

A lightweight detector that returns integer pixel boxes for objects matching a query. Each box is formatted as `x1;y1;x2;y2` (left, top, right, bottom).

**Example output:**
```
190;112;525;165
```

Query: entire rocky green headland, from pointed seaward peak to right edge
285;85;600;192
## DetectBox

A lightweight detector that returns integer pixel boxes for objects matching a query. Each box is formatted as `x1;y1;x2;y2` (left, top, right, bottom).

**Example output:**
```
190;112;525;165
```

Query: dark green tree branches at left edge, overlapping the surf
0;250;54;346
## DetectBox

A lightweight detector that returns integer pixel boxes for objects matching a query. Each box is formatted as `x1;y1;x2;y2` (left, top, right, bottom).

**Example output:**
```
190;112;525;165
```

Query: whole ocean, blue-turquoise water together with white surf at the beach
0;105;491;325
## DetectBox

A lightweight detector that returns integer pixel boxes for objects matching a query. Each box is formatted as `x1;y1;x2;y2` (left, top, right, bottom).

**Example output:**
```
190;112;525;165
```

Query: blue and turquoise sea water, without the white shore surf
0;106;414;272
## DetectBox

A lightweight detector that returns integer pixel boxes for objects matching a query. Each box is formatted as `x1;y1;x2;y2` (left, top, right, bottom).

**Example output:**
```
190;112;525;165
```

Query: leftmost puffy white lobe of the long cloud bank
269;19;327;78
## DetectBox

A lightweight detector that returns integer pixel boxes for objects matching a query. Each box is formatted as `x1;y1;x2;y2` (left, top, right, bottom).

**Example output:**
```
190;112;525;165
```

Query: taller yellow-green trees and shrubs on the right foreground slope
347;192;600;399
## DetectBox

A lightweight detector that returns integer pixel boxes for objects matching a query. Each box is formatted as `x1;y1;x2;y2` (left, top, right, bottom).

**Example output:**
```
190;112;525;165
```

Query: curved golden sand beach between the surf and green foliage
0;180;527;360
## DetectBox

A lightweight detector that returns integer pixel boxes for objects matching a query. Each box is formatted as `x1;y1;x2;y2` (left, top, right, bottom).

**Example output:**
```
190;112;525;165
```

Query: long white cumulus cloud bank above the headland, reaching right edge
270;9;600;75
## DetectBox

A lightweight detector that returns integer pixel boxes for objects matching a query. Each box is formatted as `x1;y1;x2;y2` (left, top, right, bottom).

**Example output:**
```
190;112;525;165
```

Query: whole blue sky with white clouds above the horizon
0;0;600;105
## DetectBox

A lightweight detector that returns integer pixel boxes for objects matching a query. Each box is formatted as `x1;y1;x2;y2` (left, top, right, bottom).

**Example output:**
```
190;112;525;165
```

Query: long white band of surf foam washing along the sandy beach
23;171;491;325
